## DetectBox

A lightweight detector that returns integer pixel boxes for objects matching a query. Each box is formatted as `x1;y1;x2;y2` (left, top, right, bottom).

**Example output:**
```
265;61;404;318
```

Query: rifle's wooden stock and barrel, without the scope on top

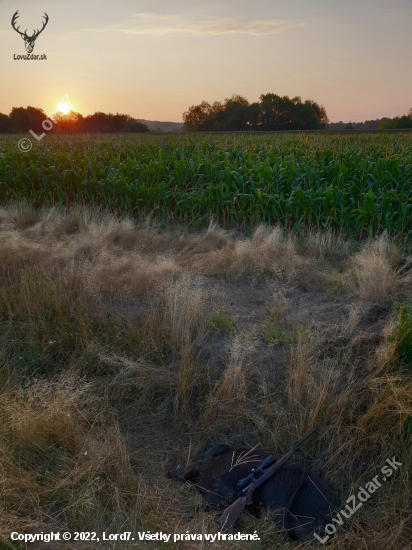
217;428;318;533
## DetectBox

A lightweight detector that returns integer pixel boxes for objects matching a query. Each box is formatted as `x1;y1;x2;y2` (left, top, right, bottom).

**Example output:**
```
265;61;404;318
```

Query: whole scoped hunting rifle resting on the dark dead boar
217;428;319;533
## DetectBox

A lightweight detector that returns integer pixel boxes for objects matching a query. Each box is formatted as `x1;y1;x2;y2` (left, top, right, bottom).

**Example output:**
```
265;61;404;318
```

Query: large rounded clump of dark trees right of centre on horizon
183;94;329;132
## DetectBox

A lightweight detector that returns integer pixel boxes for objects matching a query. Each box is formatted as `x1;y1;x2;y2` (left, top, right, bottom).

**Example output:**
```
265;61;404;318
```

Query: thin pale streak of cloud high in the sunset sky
122;13;304;35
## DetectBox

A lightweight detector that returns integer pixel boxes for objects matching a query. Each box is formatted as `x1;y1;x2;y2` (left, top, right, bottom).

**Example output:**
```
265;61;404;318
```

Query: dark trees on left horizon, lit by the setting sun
0;106;150;134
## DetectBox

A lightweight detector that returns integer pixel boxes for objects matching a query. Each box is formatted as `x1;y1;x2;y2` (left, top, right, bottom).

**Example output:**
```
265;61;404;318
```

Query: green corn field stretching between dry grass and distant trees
0;133;412;241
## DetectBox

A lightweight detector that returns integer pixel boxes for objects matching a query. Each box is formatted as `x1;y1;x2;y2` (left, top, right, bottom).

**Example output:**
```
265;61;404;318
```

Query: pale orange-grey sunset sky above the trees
0;0;412;122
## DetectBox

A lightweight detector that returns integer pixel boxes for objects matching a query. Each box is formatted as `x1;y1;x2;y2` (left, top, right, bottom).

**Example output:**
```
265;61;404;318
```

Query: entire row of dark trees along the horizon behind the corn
0;103;412;134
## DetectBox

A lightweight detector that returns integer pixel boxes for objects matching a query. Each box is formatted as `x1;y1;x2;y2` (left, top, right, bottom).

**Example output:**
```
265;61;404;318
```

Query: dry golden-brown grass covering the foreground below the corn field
0;204;412;550
